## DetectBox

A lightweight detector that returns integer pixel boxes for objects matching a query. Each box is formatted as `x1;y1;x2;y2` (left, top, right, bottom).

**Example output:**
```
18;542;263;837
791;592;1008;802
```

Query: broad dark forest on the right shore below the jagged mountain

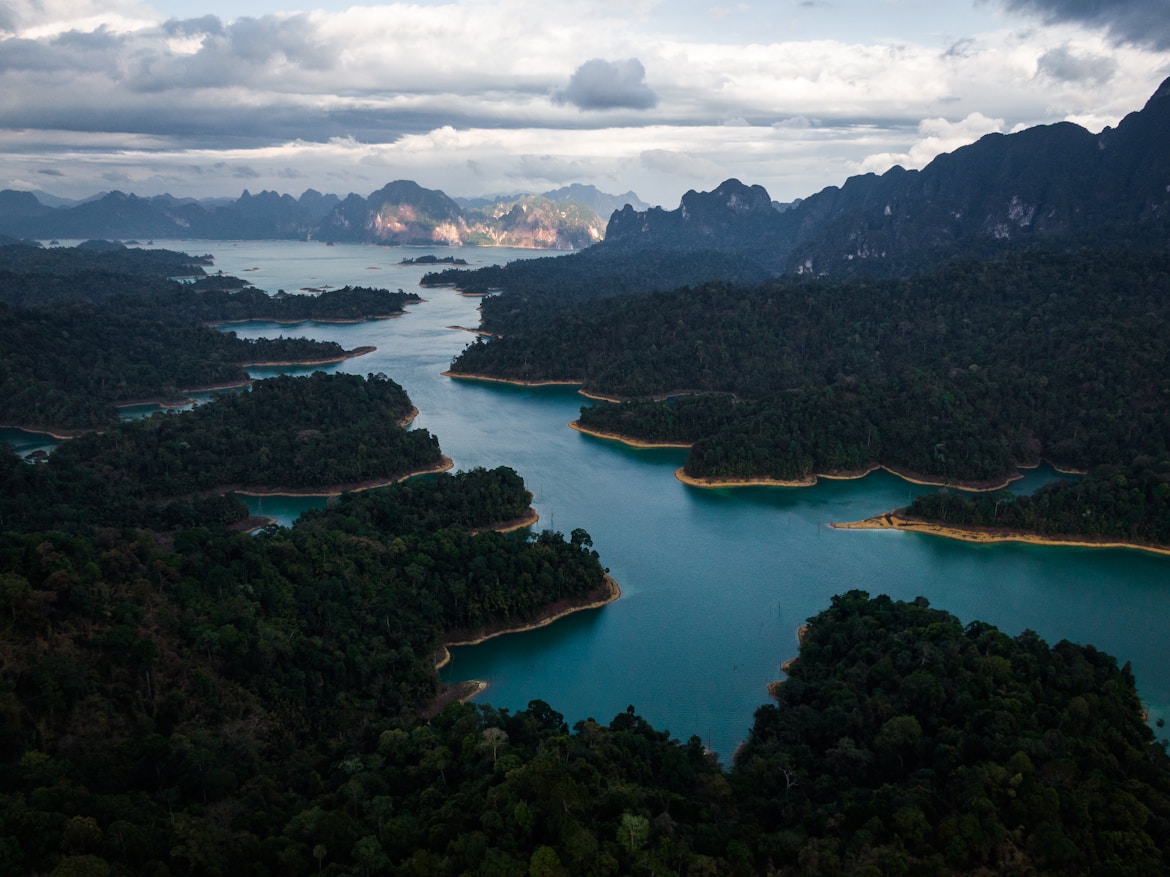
453;251;1170;482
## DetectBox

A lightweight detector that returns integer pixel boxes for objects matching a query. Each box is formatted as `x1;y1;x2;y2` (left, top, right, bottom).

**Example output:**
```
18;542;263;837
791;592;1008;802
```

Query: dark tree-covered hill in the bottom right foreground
732;592;1170;876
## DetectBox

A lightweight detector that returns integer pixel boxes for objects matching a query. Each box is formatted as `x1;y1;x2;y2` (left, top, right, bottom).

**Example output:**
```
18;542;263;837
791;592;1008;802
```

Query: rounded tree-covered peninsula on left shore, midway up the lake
47;372;442;497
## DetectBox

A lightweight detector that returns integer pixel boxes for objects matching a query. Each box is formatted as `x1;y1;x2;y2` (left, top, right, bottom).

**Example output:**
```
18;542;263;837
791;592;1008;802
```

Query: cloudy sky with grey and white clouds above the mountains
0;0;1170;208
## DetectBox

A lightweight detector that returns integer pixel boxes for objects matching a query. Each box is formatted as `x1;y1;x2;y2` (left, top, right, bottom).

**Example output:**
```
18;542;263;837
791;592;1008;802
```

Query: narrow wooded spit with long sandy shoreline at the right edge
902;457;1170;546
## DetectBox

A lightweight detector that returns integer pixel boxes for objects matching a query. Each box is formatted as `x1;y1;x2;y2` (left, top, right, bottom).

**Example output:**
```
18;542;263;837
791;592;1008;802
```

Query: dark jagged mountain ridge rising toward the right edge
601;80;1170;274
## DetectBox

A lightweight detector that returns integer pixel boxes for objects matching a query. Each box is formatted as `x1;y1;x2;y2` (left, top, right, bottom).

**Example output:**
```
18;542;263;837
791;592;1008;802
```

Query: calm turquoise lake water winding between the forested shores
134;241;1170;761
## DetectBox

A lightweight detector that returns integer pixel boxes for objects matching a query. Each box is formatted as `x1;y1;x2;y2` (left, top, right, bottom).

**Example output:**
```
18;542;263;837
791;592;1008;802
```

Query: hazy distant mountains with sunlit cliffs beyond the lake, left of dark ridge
0;180;647;249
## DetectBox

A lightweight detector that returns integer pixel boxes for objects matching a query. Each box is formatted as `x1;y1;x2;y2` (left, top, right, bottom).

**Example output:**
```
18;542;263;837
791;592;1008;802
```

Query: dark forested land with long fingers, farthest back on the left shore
0;244;430;434
